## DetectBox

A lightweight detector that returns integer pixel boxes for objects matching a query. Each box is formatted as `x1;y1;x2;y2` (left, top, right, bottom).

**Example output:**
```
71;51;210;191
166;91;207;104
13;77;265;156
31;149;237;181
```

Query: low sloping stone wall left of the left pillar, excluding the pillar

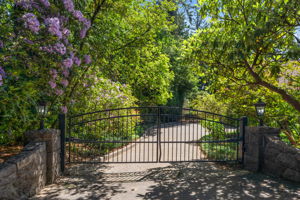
0;143;46;199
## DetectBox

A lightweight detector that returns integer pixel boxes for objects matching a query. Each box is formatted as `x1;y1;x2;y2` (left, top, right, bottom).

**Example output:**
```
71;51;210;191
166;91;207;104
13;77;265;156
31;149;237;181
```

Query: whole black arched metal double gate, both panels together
60;107;247;164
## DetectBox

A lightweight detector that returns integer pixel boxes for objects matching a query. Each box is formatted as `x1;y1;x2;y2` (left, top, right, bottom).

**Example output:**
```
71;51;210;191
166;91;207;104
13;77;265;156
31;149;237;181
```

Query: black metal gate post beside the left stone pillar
58;114;66;173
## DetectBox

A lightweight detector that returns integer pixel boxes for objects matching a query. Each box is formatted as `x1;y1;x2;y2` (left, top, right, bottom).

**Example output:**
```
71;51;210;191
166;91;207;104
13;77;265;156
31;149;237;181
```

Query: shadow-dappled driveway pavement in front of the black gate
32;163;300;200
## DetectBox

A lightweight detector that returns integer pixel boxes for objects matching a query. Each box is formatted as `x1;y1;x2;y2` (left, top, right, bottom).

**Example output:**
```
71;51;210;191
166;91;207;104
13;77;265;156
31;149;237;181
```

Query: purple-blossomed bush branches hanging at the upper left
0;0;91;112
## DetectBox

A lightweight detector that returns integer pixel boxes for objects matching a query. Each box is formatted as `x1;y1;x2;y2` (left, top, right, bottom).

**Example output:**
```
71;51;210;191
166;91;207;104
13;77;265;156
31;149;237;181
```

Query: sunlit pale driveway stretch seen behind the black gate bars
100;123;208;162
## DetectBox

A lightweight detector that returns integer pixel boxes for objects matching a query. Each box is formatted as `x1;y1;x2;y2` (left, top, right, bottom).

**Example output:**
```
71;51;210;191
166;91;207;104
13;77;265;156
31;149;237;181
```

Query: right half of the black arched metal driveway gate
160;107;241;162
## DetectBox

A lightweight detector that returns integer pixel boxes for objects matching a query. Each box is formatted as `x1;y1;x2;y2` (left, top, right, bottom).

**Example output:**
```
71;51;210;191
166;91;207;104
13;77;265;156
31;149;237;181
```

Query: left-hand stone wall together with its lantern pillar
0;129;61;200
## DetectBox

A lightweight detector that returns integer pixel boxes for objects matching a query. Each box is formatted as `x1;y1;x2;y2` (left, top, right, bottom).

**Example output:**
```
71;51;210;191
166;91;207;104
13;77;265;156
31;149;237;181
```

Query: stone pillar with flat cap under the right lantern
243;126;280;172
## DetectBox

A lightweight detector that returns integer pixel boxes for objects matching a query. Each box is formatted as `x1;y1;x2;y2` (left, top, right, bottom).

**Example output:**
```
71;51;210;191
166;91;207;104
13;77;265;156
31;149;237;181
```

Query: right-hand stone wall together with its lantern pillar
244;127;300;182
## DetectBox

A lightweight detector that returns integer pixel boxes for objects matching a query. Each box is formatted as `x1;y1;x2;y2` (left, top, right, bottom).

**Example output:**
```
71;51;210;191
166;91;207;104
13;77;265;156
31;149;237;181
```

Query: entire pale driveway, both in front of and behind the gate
32;124;300;200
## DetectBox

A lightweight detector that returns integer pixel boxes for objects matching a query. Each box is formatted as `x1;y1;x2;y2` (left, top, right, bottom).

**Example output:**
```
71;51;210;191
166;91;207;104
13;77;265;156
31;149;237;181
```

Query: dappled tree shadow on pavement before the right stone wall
138;163;300;200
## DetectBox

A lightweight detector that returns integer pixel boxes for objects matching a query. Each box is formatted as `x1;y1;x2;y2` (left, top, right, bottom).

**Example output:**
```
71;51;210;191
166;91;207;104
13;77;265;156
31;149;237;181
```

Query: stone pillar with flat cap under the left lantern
25;129;61;184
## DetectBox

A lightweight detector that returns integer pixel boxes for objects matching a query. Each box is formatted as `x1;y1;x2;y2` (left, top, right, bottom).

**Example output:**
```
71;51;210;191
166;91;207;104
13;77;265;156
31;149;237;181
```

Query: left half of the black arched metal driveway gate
66;107;158;163
